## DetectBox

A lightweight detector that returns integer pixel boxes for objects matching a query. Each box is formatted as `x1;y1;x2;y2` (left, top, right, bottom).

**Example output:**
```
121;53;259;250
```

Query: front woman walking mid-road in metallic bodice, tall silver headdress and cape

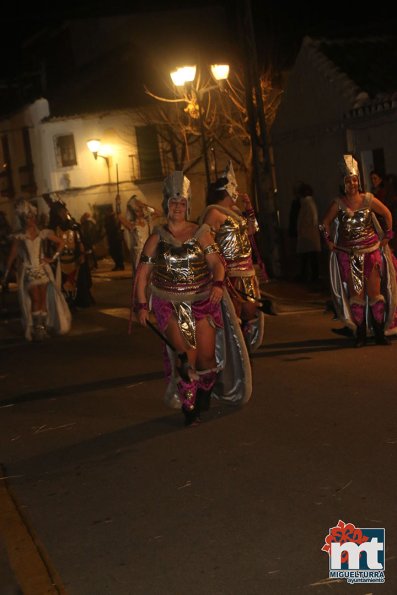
133;171;252;425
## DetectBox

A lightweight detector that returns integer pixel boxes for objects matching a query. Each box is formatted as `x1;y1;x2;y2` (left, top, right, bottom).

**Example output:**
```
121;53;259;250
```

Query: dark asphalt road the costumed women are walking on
0;275;397;595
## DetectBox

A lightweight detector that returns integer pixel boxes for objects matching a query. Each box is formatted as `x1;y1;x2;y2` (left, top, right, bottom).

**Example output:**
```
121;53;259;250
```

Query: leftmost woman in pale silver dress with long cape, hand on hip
3;200;71;341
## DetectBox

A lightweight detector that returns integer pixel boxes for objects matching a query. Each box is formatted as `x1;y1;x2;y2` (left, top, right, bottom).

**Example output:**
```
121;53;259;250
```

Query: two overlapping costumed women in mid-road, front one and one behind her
132;163;264;426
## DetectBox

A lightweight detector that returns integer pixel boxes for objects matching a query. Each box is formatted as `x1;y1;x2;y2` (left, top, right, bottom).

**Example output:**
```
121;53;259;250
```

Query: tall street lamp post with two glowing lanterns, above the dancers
170;64;229;187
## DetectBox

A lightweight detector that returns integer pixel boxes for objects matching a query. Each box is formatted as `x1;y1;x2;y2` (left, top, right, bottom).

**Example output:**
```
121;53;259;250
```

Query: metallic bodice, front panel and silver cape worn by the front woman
142;224;252;408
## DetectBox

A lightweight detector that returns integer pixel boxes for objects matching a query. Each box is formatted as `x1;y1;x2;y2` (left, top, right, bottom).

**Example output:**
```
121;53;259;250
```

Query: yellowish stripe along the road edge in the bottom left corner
0;465;67;595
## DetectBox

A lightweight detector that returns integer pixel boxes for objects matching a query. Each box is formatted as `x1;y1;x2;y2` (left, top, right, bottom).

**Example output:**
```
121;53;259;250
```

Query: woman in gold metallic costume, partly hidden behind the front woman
200;161;265;353
